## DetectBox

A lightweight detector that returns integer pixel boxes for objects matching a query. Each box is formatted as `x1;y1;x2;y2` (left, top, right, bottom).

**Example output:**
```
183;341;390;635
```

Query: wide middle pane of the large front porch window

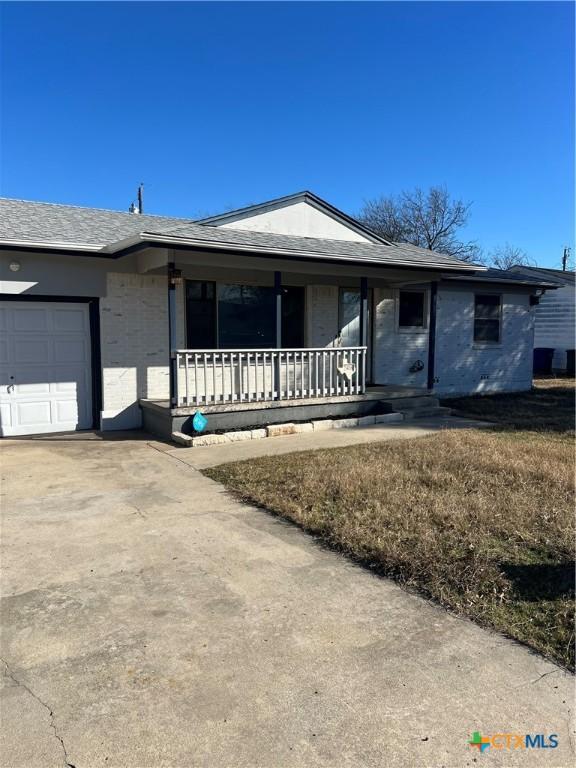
218;285;276;349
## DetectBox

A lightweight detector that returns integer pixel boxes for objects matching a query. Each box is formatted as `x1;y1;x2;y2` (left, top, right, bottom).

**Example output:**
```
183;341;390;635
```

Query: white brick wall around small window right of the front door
373;288;428;387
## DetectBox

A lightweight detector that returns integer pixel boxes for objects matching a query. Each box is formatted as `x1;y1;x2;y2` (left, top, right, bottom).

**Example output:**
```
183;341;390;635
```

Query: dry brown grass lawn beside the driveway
207;379;574;668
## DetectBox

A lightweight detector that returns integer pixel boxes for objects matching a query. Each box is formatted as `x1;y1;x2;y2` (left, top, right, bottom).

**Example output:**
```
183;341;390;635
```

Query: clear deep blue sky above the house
0;2;574;266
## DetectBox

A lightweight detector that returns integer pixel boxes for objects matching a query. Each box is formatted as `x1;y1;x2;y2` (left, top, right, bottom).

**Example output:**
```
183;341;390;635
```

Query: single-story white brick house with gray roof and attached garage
0;192;554;436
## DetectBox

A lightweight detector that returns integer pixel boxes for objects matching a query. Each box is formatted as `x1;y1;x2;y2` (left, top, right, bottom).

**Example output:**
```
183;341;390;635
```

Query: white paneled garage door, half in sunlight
0;301;92;437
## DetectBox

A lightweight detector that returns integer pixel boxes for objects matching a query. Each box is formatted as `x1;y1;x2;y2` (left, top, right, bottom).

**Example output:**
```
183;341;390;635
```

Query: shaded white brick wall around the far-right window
434;288;534;395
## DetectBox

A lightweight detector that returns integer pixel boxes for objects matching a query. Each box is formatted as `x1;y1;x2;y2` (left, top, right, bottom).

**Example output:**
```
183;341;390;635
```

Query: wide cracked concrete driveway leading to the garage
1;435;573;768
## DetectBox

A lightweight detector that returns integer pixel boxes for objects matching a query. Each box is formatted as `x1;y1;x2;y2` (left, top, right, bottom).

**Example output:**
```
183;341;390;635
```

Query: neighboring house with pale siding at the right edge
512;267;576;371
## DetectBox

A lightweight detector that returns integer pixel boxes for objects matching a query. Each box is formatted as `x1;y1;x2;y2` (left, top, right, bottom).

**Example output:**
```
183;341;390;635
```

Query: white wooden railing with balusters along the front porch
173;347;366;406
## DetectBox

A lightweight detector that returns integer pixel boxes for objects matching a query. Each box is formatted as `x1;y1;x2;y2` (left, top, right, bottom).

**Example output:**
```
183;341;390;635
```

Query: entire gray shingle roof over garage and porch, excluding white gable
0;198;483;271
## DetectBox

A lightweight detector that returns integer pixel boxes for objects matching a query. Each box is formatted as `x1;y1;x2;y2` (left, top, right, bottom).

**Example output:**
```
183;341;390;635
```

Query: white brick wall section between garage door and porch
100;272;184;429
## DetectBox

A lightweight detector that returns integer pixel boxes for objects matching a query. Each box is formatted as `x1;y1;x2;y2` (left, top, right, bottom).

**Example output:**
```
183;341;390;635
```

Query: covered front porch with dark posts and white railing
130;240;450;434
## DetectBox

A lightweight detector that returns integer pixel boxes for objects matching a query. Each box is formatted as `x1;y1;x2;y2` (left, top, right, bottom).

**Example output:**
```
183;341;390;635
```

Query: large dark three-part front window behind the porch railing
186;280;304;349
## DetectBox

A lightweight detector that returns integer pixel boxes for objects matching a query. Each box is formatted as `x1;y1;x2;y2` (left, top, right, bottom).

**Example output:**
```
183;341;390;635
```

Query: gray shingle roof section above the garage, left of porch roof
0;197;192;245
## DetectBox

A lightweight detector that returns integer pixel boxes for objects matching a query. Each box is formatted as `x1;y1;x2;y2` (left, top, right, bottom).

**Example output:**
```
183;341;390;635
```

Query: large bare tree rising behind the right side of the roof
357;187;481;261
